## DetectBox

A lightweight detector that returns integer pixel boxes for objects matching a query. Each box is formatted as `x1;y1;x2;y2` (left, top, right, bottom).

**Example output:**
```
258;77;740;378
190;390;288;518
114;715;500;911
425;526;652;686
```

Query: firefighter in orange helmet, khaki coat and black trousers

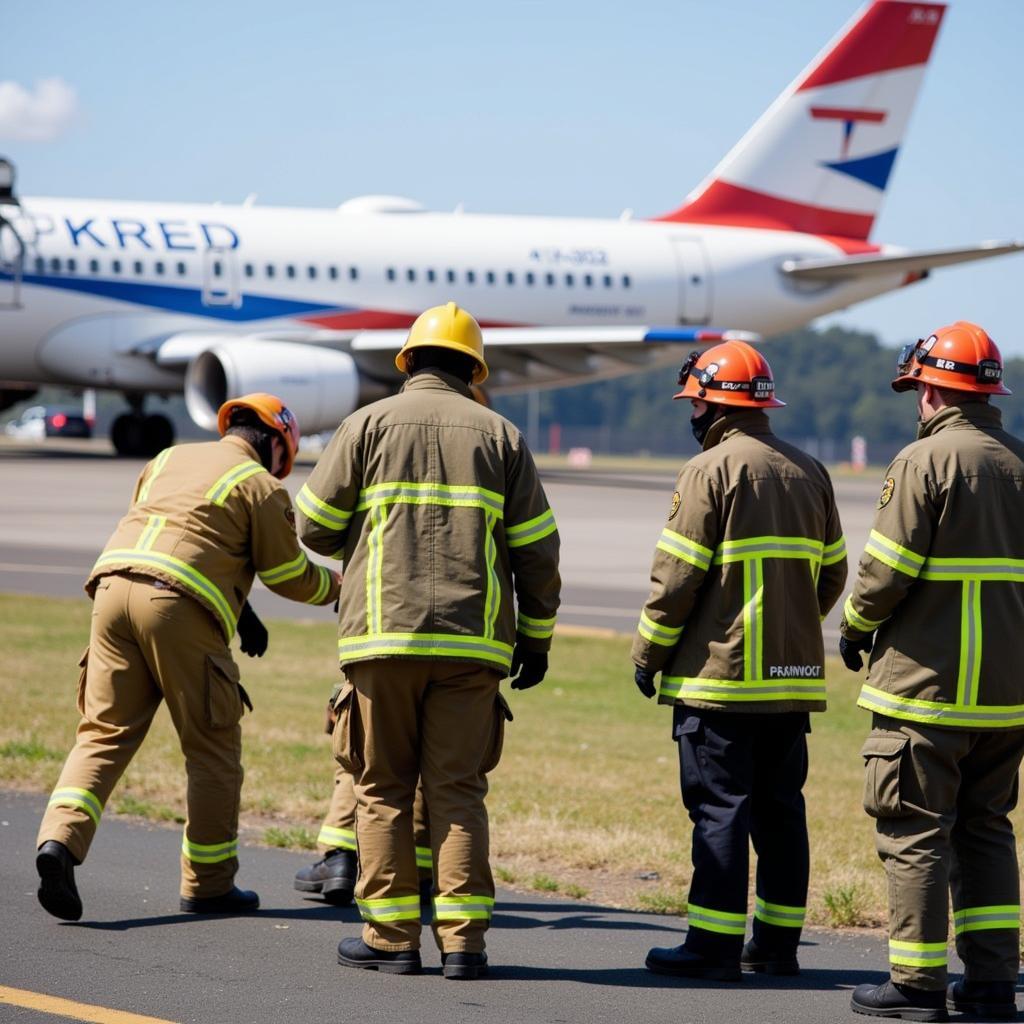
633;341;846;981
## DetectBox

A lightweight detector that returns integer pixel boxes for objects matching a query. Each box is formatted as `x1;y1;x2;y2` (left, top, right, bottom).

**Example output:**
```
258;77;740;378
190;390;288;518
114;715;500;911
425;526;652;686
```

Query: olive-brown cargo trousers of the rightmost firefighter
861;715;1024;989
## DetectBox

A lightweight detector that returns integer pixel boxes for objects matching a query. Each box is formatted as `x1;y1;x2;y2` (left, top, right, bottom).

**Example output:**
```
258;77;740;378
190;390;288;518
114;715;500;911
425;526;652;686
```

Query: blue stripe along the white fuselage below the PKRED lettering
0;272;344;322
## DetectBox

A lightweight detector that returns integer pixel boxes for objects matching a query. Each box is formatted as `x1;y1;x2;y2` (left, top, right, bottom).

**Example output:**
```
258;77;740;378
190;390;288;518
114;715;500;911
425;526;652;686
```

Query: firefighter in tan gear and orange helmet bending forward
36;394;339;921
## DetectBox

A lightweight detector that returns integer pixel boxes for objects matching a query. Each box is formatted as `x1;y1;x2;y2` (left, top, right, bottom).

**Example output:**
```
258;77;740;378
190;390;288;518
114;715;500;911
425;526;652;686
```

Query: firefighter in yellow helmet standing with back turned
296;302;559;979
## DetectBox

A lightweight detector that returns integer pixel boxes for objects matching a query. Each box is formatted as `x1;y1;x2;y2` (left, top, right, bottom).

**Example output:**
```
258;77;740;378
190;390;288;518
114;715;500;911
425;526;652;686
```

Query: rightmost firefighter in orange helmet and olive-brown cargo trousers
840;321;1024;1021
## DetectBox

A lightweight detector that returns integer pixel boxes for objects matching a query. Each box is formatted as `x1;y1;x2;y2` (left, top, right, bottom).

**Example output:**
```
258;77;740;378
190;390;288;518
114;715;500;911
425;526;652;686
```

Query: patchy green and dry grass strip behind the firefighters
0;595;1022;925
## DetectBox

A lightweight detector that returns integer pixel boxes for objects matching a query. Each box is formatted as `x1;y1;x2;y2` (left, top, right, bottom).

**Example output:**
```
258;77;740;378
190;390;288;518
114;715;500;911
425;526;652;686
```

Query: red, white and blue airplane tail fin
655;0;945;241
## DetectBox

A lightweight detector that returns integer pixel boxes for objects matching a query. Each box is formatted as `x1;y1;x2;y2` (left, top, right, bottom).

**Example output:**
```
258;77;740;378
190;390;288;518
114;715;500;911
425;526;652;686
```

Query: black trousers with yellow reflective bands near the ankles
673;707;810;959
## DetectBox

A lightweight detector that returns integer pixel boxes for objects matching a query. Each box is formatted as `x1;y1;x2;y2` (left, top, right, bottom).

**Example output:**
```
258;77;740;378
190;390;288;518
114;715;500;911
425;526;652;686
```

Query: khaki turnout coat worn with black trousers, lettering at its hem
633;410;847;712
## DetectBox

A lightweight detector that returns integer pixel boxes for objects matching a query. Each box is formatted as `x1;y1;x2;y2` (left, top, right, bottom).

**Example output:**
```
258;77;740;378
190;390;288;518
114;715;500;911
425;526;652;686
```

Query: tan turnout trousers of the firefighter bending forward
37;574;242;898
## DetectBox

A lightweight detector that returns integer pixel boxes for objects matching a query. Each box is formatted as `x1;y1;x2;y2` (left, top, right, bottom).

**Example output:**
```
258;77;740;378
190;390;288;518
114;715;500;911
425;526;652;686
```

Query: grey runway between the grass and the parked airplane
0;443;882;647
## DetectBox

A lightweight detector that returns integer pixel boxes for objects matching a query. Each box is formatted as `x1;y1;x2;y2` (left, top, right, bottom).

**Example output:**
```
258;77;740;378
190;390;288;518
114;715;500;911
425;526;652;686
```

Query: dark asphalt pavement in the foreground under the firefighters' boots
0;791;913;1024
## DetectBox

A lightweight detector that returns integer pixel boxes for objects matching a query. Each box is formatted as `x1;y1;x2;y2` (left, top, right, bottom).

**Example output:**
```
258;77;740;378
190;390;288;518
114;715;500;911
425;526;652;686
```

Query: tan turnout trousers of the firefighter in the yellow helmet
334;658;506;952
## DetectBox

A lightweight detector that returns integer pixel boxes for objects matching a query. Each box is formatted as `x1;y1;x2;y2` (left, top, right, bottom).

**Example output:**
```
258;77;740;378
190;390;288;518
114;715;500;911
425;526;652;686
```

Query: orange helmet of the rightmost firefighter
893;321;1013;394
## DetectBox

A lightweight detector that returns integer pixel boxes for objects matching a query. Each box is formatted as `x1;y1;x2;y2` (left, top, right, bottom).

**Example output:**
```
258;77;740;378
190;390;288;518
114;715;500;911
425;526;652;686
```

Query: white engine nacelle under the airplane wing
185;340;359;434
